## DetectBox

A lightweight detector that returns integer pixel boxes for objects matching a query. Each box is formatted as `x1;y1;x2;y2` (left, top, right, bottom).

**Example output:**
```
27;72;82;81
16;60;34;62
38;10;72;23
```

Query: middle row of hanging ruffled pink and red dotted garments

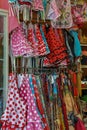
10;23;81;66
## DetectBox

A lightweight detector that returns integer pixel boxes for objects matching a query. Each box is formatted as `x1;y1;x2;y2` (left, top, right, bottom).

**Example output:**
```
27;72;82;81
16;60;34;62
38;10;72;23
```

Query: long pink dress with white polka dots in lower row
20;76;43;130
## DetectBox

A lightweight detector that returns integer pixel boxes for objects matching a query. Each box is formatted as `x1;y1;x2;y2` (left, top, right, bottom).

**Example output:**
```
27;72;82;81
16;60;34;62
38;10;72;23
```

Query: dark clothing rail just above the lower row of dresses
12;66;75;75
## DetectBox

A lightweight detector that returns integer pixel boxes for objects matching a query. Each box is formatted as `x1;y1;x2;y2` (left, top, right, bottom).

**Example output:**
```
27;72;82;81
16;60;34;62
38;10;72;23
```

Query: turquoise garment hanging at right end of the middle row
70;30;82;57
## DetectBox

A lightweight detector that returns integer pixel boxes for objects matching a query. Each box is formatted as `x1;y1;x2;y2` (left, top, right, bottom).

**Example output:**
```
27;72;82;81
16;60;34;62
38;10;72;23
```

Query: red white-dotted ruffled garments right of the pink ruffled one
28;24;48;56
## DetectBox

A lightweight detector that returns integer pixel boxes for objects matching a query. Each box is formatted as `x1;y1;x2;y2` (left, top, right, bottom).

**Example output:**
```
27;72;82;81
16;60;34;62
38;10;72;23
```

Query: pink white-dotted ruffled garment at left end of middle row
11;27;33;57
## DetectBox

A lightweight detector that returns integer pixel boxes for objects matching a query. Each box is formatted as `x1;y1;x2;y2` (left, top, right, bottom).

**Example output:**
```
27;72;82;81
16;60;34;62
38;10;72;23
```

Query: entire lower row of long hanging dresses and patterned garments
1;71;84;130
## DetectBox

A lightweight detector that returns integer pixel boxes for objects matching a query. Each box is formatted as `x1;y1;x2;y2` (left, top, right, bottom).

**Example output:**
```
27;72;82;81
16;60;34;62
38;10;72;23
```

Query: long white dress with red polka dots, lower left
1;74;26;130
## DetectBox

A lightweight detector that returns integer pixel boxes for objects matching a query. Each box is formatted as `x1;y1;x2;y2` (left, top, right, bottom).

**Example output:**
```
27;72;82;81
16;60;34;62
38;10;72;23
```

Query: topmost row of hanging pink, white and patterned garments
8;0;87;32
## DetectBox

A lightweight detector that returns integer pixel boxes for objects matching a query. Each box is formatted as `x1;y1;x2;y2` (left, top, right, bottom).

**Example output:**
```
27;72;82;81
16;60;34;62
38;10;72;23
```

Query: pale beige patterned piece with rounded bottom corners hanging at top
51;0;72;28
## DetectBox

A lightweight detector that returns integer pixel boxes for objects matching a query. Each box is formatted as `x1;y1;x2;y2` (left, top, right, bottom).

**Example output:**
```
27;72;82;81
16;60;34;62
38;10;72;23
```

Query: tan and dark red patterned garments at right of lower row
57;71;81;130
